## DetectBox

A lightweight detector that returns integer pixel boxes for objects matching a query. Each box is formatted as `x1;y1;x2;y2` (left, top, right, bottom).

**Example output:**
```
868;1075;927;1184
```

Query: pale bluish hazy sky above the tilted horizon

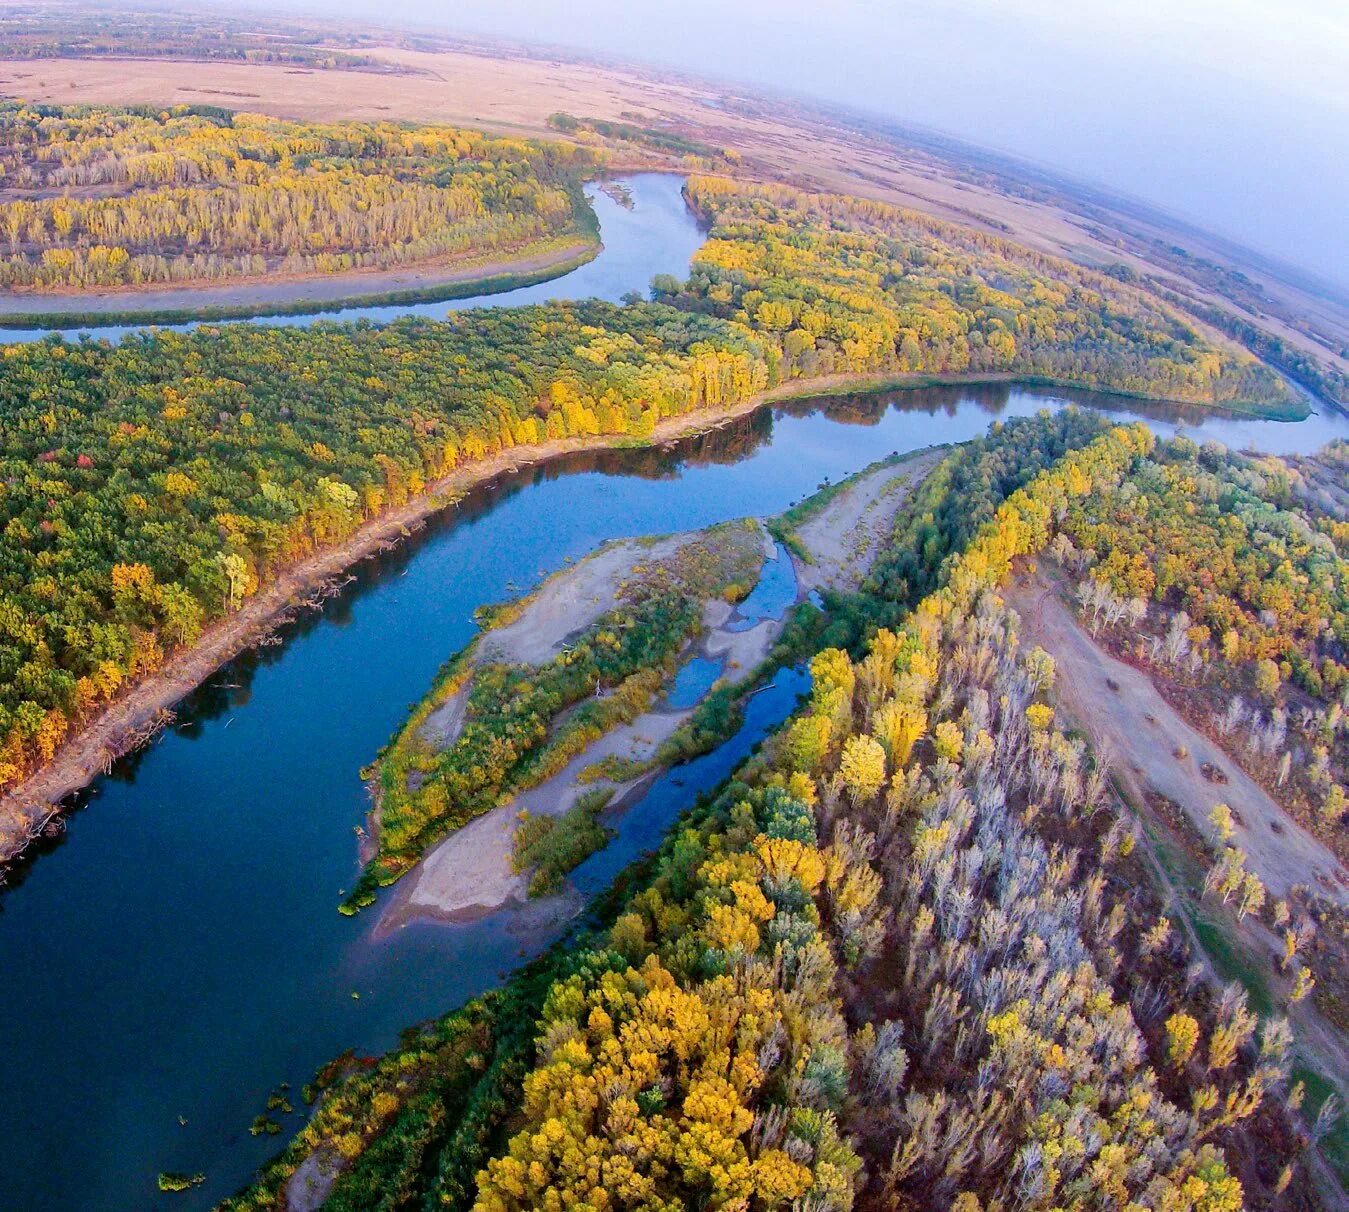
297;0;1349;285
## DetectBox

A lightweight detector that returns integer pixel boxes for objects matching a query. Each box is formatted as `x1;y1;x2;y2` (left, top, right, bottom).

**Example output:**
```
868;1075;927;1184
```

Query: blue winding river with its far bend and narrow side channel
0;177;1349;1212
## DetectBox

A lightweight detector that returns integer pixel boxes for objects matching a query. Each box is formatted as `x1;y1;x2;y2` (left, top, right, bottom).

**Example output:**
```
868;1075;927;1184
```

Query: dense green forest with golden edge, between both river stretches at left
0;304;768;831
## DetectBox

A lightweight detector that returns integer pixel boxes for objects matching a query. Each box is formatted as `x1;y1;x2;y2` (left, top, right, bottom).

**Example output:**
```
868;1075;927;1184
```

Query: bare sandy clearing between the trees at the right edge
1004;572;1349;907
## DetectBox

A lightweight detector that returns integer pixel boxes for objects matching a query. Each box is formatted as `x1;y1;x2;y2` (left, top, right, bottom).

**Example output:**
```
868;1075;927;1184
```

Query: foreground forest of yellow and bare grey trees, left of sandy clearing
215;413;1332;1212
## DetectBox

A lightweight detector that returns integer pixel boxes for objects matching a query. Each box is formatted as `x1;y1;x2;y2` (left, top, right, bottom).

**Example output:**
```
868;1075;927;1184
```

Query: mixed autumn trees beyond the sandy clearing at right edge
1054;437;1349;856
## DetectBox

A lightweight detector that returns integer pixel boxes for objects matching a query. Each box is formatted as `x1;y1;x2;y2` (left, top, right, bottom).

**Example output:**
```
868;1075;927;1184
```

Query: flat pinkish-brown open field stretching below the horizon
0;46;1349;371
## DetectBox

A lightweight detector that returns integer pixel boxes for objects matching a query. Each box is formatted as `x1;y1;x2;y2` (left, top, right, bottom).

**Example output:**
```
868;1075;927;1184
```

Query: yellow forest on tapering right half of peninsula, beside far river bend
669;177;1300;414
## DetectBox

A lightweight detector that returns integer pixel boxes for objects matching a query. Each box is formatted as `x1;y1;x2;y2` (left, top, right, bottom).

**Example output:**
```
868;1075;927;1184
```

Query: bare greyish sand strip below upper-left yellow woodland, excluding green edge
0;240;596;316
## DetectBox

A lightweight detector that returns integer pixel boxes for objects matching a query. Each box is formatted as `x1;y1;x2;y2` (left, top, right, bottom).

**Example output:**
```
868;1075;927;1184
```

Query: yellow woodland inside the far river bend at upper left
0;103;595;289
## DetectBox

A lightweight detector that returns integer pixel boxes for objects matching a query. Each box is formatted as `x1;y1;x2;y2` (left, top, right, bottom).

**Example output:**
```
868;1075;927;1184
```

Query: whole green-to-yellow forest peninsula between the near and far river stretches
0;165;1292;827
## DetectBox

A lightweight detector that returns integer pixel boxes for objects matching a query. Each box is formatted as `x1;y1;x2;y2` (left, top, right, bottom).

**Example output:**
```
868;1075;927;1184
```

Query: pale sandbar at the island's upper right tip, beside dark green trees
793;449;946;598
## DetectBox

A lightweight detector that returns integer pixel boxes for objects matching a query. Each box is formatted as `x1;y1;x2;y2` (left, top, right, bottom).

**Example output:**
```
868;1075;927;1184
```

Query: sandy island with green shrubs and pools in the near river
369;451;940;930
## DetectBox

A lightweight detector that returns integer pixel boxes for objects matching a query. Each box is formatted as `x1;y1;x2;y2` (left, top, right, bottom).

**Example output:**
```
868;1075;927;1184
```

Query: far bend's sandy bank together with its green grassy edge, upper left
0;238;604;331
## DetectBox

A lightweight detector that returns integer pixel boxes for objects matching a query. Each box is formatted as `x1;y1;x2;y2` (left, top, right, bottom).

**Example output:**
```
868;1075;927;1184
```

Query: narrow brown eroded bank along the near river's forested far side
0;374;1316;862
